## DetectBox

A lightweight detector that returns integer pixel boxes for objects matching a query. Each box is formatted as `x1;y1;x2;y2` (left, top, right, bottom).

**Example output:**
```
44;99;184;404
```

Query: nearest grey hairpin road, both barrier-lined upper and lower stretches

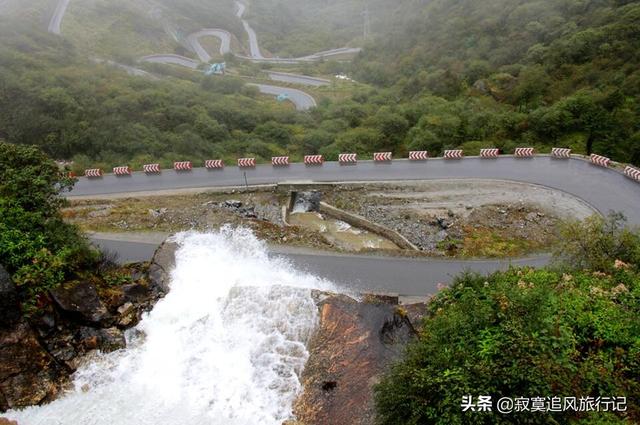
80;155;640;296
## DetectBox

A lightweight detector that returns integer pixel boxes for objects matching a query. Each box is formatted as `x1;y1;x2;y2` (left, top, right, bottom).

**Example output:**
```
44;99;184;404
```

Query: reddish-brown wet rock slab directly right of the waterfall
294;295;415;425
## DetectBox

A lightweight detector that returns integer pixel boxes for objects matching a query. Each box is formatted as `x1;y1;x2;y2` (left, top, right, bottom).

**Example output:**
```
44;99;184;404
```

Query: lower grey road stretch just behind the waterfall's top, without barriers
92;235;549;296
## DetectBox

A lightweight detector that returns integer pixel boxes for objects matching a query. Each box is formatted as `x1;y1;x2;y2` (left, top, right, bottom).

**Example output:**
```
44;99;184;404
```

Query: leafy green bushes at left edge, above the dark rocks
0;142;131;315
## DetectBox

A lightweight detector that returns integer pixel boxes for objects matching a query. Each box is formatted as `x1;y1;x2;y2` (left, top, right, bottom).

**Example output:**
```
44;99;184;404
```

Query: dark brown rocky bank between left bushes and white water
0;240;174;412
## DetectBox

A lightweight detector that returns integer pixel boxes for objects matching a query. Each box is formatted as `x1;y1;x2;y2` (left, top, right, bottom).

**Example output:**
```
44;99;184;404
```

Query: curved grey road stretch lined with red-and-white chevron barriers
70;155;640;225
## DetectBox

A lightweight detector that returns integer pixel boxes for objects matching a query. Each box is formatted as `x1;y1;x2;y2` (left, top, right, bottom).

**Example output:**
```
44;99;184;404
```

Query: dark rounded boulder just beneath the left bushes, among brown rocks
49;282;110;323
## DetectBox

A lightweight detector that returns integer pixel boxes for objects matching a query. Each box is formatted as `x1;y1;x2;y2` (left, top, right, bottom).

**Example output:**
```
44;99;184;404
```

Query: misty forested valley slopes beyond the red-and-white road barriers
0;0;640;169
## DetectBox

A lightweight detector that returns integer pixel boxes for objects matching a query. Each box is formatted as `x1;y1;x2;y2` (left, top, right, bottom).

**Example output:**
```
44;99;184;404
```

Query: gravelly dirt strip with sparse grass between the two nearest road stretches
64;180;595;257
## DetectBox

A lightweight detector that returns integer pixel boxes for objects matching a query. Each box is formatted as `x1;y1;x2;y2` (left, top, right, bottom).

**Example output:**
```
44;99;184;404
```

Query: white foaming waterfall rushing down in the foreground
7;228;331;425
